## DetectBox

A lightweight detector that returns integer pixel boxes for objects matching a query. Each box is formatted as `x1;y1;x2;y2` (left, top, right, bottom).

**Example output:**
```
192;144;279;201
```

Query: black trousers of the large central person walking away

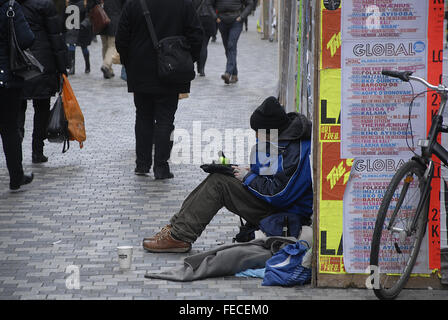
134;92;179;169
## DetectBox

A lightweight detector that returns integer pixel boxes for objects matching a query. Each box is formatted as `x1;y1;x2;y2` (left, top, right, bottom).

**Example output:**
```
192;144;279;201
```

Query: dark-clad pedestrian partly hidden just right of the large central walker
193;0;216;77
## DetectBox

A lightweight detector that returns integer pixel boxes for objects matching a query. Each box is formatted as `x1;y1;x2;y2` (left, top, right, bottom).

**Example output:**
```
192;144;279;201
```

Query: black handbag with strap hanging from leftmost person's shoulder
6;0;44;80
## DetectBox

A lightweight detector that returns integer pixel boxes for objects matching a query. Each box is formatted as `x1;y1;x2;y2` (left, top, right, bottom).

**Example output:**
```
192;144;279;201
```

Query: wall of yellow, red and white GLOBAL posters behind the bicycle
318;0;445;273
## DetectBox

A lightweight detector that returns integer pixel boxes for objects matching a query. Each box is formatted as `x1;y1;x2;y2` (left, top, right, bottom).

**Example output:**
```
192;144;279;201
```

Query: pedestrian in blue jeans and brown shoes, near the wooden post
210;0;253;84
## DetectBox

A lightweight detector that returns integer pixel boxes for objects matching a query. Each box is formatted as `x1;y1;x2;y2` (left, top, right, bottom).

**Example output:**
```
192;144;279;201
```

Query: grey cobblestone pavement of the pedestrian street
0;16;448;300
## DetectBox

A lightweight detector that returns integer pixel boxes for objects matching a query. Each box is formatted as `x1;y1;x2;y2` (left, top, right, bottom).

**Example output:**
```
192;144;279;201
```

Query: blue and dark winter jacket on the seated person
243;113;313;218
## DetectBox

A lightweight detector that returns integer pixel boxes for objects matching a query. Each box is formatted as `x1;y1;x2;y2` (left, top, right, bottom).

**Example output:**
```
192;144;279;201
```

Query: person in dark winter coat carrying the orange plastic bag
19;0;67;163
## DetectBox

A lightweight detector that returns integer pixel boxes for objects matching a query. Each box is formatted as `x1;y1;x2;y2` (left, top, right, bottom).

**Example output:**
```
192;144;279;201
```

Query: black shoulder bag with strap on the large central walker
140;0;196;84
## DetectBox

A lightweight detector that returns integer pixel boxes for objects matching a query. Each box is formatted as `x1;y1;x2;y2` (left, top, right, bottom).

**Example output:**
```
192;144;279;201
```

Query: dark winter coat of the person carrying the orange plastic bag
20;0;67;99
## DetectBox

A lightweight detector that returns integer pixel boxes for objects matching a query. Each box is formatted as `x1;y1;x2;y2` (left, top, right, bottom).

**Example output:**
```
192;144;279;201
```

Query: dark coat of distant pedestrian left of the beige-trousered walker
65;0;93;47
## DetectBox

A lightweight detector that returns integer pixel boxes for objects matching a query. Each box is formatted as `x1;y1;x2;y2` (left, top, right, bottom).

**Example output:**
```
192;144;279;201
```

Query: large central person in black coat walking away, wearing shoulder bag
115;0;203;179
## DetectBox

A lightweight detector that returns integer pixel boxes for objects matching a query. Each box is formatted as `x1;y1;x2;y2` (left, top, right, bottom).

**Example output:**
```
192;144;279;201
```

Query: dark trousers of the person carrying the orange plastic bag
18;98;50;155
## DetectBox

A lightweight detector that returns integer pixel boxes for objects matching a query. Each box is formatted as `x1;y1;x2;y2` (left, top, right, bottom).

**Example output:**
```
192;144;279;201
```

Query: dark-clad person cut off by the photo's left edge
0;0;34;192
